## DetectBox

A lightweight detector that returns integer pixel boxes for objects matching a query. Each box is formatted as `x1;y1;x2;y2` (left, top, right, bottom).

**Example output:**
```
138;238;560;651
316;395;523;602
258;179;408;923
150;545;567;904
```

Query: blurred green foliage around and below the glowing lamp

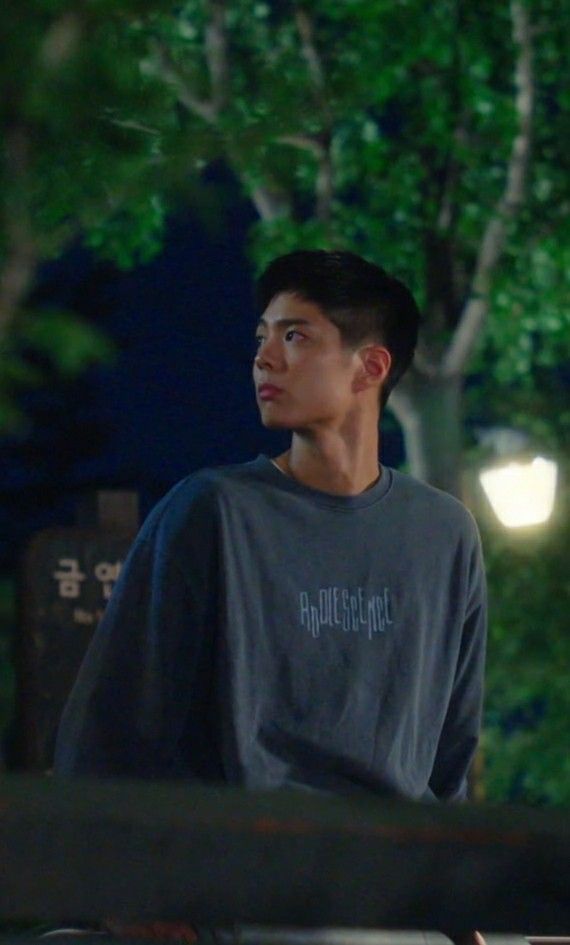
465;376;570;806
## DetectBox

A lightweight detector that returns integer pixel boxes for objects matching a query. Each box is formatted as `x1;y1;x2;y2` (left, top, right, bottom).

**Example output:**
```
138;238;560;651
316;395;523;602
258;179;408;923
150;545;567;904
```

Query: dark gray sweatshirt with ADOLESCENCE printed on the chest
55;455;486;799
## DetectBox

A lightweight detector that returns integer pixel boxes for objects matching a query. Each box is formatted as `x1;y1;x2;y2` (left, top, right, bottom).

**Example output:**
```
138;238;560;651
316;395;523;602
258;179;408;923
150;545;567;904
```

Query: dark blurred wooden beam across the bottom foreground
0;775;570;935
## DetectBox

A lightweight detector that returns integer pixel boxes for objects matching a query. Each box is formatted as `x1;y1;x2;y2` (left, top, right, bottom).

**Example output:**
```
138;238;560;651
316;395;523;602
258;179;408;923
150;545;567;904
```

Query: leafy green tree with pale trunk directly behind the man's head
127;0;570;493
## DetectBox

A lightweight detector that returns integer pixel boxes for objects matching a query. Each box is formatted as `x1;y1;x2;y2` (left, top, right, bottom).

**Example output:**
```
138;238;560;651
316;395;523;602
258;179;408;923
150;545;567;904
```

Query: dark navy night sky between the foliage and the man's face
0;183;403;572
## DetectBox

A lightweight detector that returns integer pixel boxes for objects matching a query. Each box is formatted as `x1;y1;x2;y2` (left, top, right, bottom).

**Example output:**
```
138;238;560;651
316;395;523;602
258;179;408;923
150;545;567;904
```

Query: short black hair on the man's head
255;249;421;409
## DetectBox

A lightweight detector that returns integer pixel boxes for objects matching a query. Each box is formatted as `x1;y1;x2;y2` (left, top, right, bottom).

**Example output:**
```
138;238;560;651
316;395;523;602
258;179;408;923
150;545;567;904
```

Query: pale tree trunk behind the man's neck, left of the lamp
388;368;463;498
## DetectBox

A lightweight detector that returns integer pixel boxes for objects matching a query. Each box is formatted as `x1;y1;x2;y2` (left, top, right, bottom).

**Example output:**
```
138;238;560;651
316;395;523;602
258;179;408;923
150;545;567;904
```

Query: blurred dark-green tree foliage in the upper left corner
0;0;193;432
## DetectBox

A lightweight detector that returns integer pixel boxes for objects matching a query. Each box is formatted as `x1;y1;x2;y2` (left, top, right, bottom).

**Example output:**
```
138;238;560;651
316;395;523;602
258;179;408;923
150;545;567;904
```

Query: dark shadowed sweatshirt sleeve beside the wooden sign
54;480;220;778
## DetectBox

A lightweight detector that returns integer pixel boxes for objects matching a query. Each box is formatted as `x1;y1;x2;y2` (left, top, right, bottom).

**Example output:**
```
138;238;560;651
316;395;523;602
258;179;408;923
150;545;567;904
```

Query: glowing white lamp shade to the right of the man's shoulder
479;456;558;528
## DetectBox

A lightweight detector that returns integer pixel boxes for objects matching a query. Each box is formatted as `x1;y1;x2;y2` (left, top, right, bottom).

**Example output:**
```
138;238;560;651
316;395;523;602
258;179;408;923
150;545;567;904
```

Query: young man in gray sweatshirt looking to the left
56;251;486;941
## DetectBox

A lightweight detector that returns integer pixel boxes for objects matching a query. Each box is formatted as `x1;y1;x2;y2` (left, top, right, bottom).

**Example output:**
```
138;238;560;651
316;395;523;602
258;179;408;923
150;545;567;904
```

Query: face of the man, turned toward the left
253;293;362;429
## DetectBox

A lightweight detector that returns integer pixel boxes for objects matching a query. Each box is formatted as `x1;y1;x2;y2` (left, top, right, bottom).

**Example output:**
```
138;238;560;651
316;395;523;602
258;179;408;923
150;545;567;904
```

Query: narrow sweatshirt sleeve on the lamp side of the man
429;522;487;801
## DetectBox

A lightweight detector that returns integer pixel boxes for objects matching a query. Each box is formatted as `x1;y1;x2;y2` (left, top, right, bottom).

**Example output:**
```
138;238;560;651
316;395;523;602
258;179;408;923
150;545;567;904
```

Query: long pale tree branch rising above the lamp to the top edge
441;0;534;375
